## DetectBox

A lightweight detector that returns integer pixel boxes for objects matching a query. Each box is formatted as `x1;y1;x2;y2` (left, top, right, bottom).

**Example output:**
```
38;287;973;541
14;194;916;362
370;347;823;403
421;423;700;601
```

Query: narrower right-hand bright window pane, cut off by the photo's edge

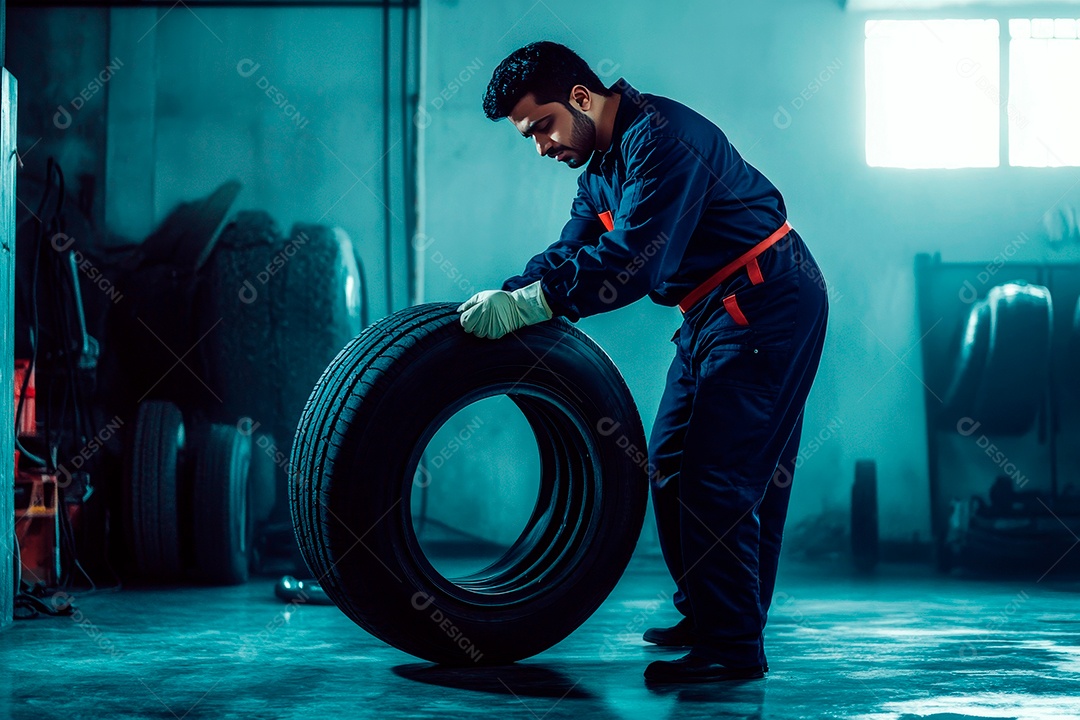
1009;18;1080;167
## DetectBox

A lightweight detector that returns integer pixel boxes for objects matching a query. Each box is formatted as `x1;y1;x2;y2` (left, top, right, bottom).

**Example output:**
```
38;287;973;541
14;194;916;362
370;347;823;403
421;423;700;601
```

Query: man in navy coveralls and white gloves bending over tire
459;42;828;682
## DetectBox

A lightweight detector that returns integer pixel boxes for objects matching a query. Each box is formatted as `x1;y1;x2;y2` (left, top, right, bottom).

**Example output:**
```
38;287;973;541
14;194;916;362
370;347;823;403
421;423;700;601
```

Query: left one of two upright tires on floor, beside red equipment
123;400;186;582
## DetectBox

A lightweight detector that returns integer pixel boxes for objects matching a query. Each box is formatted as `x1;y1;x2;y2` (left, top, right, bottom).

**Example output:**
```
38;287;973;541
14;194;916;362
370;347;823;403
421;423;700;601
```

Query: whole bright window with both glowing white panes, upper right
866;18;1080;168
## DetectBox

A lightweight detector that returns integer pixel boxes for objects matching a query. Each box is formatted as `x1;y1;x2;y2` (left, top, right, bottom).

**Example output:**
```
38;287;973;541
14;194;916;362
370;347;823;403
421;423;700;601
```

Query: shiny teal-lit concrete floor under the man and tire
0;556;1080;720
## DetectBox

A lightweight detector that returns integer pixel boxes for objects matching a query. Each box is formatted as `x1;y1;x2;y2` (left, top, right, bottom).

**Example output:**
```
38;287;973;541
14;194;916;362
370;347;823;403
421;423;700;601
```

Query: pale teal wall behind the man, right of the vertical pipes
416;0;1080;546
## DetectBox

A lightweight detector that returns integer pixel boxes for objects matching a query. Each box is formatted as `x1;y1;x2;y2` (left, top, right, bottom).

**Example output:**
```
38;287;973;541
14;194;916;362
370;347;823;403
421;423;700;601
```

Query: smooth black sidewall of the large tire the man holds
321;323;647;662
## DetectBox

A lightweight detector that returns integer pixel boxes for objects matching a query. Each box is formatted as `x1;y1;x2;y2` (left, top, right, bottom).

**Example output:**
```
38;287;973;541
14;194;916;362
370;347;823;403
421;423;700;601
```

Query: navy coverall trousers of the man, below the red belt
649;253;828;667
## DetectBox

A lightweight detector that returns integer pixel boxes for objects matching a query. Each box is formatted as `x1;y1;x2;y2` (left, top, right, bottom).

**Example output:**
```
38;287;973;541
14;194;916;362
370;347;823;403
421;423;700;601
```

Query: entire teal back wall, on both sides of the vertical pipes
9;0;1080;557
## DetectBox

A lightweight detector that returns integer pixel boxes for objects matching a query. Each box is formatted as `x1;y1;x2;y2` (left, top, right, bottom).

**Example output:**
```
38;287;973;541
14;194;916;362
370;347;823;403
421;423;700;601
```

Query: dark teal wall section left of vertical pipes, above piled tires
9;6;407;317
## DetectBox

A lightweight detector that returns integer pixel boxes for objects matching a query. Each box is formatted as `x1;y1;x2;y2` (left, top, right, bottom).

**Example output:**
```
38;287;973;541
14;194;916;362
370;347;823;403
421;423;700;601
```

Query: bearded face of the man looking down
510;93;596;167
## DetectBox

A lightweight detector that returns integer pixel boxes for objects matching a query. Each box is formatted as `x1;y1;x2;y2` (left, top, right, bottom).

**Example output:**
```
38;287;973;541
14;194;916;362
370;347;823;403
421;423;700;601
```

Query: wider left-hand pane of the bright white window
866;19;997;168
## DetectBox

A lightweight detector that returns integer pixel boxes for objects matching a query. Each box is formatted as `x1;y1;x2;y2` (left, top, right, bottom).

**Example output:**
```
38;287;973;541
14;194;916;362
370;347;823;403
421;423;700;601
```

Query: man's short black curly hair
484;40;612;120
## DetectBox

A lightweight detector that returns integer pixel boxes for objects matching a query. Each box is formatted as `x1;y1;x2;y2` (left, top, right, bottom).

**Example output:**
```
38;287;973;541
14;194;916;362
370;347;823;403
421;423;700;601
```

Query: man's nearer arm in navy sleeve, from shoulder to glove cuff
539;137;715;321
